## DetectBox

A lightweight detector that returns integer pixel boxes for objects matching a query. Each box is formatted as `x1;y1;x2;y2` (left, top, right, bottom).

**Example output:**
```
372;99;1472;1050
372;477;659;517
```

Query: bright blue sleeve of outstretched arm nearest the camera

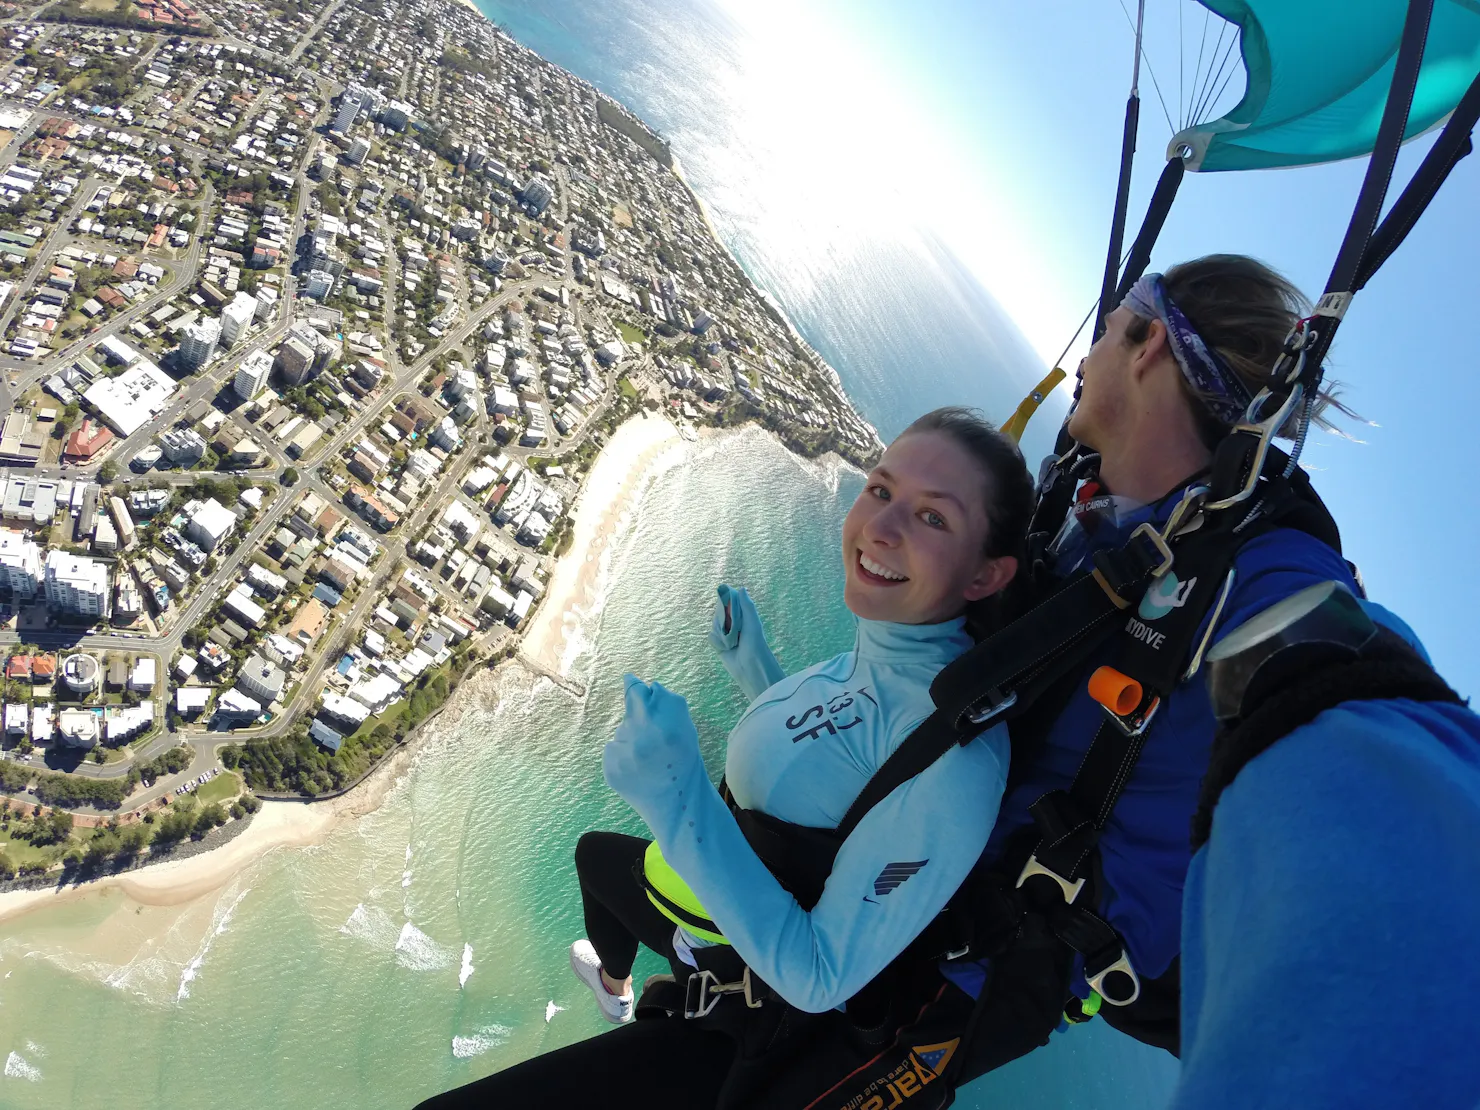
1172;702;1480;1110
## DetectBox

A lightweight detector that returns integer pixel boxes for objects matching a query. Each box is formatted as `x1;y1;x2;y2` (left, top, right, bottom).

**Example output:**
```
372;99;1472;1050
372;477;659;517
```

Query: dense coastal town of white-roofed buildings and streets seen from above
0;0;881;878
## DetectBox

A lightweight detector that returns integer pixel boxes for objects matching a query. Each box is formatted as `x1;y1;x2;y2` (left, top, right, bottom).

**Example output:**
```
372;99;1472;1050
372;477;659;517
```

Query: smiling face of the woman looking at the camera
842;432;1015;625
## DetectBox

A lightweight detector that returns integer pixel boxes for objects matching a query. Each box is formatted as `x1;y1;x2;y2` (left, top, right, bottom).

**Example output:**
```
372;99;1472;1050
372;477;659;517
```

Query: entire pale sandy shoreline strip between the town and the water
0;413;685;922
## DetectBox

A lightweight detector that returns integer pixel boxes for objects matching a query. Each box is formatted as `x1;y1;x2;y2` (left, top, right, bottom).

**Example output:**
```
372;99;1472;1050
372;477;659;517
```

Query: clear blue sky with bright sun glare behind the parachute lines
713;0;1480;693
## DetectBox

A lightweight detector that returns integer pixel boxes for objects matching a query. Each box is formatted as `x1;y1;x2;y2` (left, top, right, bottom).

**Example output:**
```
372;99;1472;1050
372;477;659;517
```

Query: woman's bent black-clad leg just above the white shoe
576;832;673;980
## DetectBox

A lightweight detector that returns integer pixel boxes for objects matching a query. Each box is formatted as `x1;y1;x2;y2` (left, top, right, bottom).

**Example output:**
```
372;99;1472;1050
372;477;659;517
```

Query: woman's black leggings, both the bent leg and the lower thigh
417;832;736;1110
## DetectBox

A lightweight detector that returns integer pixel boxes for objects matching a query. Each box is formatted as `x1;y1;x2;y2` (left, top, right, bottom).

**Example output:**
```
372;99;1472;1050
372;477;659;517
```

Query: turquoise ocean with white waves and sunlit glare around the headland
0;0;1175;1110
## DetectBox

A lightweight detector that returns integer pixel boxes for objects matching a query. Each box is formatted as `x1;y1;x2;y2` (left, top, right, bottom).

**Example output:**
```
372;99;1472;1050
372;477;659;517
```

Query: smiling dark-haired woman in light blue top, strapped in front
425;408;1033;1107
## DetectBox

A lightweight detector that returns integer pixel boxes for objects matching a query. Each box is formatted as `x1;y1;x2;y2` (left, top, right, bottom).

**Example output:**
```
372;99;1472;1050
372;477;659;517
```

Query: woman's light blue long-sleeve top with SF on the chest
608;591;1008;1012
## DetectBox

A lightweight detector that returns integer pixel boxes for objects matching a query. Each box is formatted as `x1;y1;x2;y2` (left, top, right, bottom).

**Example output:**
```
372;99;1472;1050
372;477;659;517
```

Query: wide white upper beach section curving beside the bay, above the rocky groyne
521;414;684;675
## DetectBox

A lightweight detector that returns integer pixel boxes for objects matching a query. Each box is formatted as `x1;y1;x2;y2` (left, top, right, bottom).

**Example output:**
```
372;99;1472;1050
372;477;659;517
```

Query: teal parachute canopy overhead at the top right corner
1168;0;1480;173
